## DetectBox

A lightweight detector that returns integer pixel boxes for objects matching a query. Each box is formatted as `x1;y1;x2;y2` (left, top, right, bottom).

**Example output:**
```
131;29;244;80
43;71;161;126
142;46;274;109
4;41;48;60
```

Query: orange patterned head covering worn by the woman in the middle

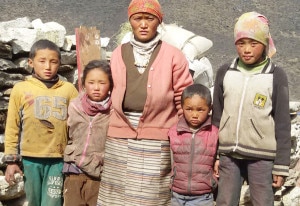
128;0;163;23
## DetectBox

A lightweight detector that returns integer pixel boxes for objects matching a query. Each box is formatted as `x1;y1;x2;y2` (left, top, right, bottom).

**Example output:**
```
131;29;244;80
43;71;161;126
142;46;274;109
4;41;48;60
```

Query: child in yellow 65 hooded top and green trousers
4;40;78;206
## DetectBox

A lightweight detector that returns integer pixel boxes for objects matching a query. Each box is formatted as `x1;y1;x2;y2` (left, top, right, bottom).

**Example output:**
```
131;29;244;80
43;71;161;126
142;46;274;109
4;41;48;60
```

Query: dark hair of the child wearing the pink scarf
82;60;114;91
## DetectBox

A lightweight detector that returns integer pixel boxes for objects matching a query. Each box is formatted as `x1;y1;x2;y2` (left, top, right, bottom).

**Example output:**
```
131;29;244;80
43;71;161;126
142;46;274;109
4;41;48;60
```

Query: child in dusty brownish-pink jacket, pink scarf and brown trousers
63;60;113;206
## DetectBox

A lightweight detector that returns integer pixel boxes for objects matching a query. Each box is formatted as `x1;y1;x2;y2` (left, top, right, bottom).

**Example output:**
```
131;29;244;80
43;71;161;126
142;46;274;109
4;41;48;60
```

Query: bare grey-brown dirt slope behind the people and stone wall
0;0;300;101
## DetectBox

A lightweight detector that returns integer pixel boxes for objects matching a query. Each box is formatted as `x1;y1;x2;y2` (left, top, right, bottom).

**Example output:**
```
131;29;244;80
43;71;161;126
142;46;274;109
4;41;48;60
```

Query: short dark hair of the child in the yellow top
29;39;61;60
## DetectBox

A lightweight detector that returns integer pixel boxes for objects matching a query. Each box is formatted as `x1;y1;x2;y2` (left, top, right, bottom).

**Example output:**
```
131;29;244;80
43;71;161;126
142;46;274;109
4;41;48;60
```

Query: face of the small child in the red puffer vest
182;95;211;129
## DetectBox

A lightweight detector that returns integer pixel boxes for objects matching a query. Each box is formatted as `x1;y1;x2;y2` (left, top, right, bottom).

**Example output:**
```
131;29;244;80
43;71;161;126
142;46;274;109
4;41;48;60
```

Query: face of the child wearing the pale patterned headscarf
235;38;265;65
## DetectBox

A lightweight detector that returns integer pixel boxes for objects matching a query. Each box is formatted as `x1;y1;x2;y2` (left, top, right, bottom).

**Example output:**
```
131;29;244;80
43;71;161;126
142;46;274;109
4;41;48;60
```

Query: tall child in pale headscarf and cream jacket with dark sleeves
213;12;291;206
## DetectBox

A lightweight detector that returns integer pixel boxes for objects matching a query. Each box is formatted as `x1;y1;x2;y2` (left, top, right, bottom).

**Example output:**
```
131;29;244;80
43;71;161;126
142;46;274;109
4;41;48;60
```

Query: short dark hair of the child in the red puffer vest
181;84;212;106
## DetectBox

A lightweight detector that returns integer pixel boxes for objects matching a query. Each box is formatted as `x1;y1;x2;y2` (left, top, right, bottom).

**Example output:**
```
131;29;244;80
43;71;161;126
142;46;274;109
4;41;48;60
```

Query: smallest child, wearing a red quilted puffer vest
169;84;218;206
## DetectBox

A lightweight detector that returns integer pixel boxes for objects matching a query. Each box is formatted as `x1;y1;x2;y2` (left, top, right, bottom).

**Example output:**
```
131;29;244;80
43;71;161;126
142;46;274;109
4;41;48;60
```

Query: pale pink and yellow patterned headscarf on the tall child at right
234;11;276;57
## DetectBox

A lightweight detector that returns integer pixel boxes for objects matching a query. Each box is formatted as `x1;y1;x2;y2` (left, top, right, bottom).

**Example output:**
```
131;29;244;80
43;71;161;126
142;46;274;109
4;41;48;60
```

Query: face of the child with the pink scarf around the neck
84;68;110;102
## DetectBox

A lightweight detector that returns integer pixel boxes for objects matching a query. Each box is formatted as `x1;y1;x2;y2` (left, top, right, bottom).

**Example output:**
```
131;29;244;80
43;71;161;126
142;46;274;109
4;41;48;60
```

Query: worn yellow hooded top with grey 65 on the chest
4;78;78;162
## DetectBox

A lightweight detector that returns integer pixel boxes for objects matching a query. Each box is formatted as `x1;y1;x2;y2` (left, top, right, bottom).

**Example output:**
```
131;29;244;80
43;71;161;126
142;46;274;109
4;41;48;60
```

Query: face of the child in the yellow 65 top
28;49;60;80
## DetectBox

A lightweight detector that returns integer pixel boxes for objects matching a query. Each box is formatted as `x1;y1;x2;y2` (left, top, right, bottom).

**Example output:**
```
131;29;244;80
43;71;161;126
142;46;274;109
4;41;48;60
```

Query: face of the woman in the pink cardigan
129;13;160;43
